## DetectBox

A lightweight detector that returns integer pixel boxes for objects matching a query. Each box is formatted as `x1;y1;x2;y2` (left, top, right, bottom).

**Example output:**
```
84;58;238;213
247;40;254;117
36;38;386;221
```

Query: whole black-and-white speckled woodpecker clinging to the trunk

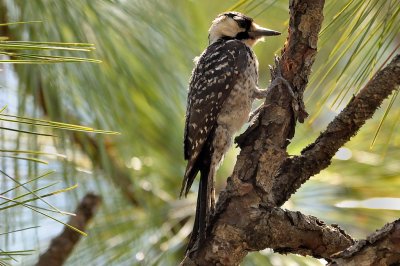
180;11;280;249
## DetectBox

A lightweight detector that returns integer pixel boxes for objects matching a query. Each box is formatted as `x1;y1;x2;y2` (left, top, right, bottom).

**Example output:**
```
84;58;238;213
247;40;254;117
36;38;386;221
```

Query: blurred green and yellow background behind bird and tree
0;0;400;265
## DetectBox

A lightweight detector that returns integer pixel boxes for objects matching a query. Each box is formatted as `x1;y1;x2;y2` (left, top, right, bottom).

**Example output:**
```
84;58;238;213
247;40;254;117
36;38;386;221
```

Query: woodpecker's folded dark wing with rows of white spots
184;40;249;176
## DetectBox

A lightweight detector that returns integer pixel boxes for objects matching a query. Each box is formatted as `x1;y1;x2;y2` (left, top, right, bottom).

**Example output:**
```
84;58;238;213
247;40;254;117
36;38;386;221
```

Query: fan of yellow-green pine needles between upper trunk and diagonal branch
310;0;400;117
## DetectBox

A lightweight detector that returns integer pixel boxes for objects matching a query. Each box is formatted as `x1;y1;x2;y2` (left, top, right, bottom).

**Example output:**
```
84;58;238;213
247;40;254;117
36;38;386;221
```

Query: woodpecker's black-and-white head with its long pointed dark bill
208;11;281;47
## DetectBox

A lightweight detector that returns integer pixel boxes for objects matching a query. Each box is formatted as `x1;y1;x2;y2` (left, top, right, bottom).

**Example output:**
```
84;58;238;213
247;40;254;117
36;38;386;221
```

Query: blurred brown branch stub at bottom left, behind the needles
36;193;101;266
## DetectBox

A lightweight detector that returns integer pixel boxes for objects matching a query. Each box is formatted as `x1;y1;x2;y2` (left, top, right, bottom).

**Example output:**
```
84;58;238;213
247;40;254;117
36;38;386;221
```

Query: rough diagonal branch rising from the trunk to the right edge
273;55;400;206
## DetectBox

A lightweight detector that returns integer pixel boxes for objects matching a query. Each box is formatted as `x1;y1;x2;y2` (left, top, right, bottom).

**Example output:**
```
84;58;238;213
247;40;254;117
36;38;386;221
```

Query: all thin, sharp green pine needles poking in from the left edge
0;19;118;265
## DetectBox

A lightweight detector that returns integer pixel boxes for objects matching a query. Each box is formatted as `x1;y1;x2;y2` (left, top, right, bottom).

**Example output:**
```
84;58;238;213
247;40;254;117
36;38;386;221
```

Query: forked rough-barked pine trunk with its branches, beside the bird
182;0;400;265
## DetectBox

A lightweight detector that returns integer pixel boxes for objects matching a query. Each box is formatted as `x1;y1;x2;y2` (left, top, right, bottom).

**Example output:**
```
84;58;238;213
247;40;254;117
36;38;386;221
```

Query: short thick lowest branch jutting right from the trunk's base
246;207;354;258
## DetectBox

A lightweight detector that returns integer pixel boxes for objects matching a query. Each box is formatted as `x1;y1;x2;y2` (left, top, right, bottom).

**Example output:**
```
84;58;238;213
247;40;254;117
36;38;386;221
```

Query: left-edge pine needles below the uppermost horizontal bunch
0;103;117;265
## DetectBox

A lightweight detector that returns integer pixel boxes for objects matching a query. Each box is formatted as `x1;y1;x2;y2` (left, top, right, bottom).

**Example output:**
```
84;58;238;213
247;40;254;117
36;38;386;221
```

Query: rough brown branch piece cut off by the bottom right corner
329;219;400;266
